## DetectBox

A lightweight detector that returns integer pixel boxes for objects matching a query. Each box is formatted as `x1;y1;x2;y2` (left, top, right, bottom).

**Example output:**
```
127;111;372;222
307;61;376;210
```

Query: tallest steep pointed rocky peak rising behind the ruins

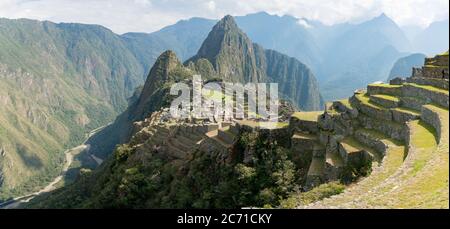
186;16;323;110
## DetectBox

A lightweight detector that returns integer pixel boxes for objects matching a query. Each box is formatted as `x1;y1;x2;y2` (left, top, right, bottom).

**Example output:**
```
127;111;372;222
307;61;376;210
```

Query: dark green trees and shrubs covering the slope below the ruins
31;132;306;208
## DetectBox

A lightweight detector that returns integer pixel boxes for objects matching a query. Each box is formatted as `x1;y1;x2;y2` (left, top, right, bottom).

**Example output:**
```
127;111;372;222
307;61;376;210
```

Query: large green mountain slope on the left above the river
0;19;144;198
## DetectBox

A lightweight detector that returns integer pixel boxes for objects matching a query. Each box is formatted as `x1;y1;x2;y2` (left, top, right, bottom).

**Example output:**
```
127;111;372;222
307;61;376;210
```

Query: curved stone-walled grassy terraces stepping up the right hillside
299;78;449;208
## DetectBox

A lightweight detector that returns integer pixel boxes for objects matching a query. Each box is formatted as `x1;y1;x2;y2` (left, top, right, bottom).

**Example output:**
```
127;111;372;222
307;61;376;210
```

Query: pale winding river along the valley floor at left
0;123;111;209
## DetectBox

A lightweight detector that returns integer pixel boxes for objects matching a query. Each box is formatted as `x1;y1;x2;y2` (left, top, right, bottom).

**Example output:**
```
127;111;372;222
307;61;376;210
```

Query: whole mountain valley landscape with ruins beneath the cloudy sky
0;3;449;209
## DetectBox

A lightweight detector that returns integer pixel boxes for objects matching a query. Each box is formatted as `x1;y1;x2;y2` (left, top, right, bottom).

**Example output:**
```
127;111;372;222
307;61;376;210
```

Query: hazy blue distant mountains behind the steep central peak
118;12;448;101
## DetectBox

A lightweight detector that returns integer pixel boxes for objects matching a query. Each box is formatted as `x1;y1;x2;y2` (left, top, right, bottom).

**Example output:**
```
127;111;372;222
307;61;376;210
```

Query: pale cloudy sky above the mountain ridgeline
0;0;449;33
